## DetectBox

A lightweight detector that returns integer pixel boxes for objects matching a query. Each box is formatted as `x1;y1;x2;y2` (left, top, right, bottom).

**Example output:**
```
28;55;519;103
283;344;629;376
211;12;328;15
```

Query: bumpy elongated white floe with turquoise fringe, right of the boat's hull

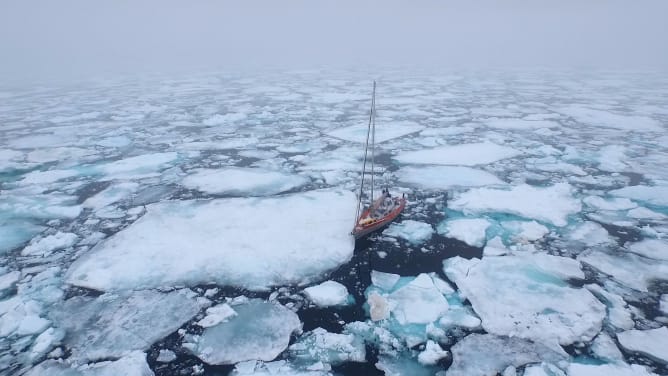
448;183;582;226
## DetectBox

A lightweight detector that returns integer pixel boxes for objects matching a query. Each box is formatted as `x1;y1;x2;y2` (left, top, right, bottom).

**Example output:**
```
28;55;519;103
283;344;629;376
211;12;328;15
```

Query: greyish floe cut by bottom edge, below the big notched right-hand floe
447;334;568;376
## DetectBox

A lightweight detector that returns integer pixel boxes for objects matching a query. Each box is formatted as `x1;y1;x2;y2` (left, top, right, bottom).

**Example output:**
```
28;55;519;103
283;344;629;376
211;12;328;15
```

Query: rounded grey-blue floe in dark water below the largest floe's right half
185;300;302;364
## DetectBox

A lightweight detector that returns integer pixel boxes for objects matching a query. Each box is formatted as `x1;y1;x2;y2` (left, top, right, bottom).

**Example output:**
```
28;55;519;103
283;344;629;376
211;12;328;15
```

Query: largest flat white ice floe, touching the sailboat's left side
67;190;355;291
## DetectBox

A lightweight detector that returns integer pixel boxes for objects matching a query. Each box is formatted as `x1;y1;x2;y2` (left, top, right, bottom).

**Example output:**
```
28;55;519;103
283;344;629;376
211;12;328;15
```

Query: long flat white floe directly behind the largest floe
182;167;309;196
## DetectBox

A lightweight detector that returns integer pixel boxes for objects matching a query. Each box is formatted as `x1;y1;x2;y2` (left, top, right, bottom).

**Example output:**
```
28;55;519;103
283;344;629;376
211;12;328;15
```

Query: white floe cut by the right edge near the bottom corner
617;326;668;364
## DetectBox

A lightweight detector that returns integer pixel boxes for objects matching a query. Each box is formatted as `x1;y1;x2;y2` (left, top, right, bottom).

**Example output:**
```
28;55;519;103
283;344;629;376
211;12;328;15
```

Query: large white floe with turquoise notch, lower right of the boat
443;254;606;347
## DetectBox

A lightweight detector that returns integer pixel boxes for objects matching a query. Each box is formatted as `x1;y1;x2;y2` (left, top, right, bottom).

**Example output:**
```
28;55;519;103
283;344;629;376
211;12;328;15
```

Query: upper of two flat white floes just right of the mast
394;142;521;166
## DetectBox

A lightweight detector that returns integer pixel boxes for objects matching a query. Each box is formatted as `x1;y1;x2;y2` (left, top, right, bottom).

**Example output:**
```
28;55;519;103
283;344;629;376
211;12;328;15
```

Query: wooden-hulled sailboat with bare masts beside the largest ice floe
351;81;406;239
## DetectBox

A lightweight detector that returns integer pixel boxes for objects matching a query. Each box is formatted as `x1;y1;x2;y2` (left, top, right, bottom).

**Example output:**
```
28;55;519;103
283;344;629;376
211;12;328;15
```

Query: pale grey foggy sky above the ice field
0;0;668;81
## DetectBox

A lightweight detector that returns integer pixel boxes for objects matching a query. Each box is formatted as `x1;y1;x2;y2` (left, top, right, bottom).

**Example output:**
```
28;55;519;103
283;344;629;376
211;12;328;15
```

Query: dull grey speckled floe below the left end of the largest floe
50;289;208;362
